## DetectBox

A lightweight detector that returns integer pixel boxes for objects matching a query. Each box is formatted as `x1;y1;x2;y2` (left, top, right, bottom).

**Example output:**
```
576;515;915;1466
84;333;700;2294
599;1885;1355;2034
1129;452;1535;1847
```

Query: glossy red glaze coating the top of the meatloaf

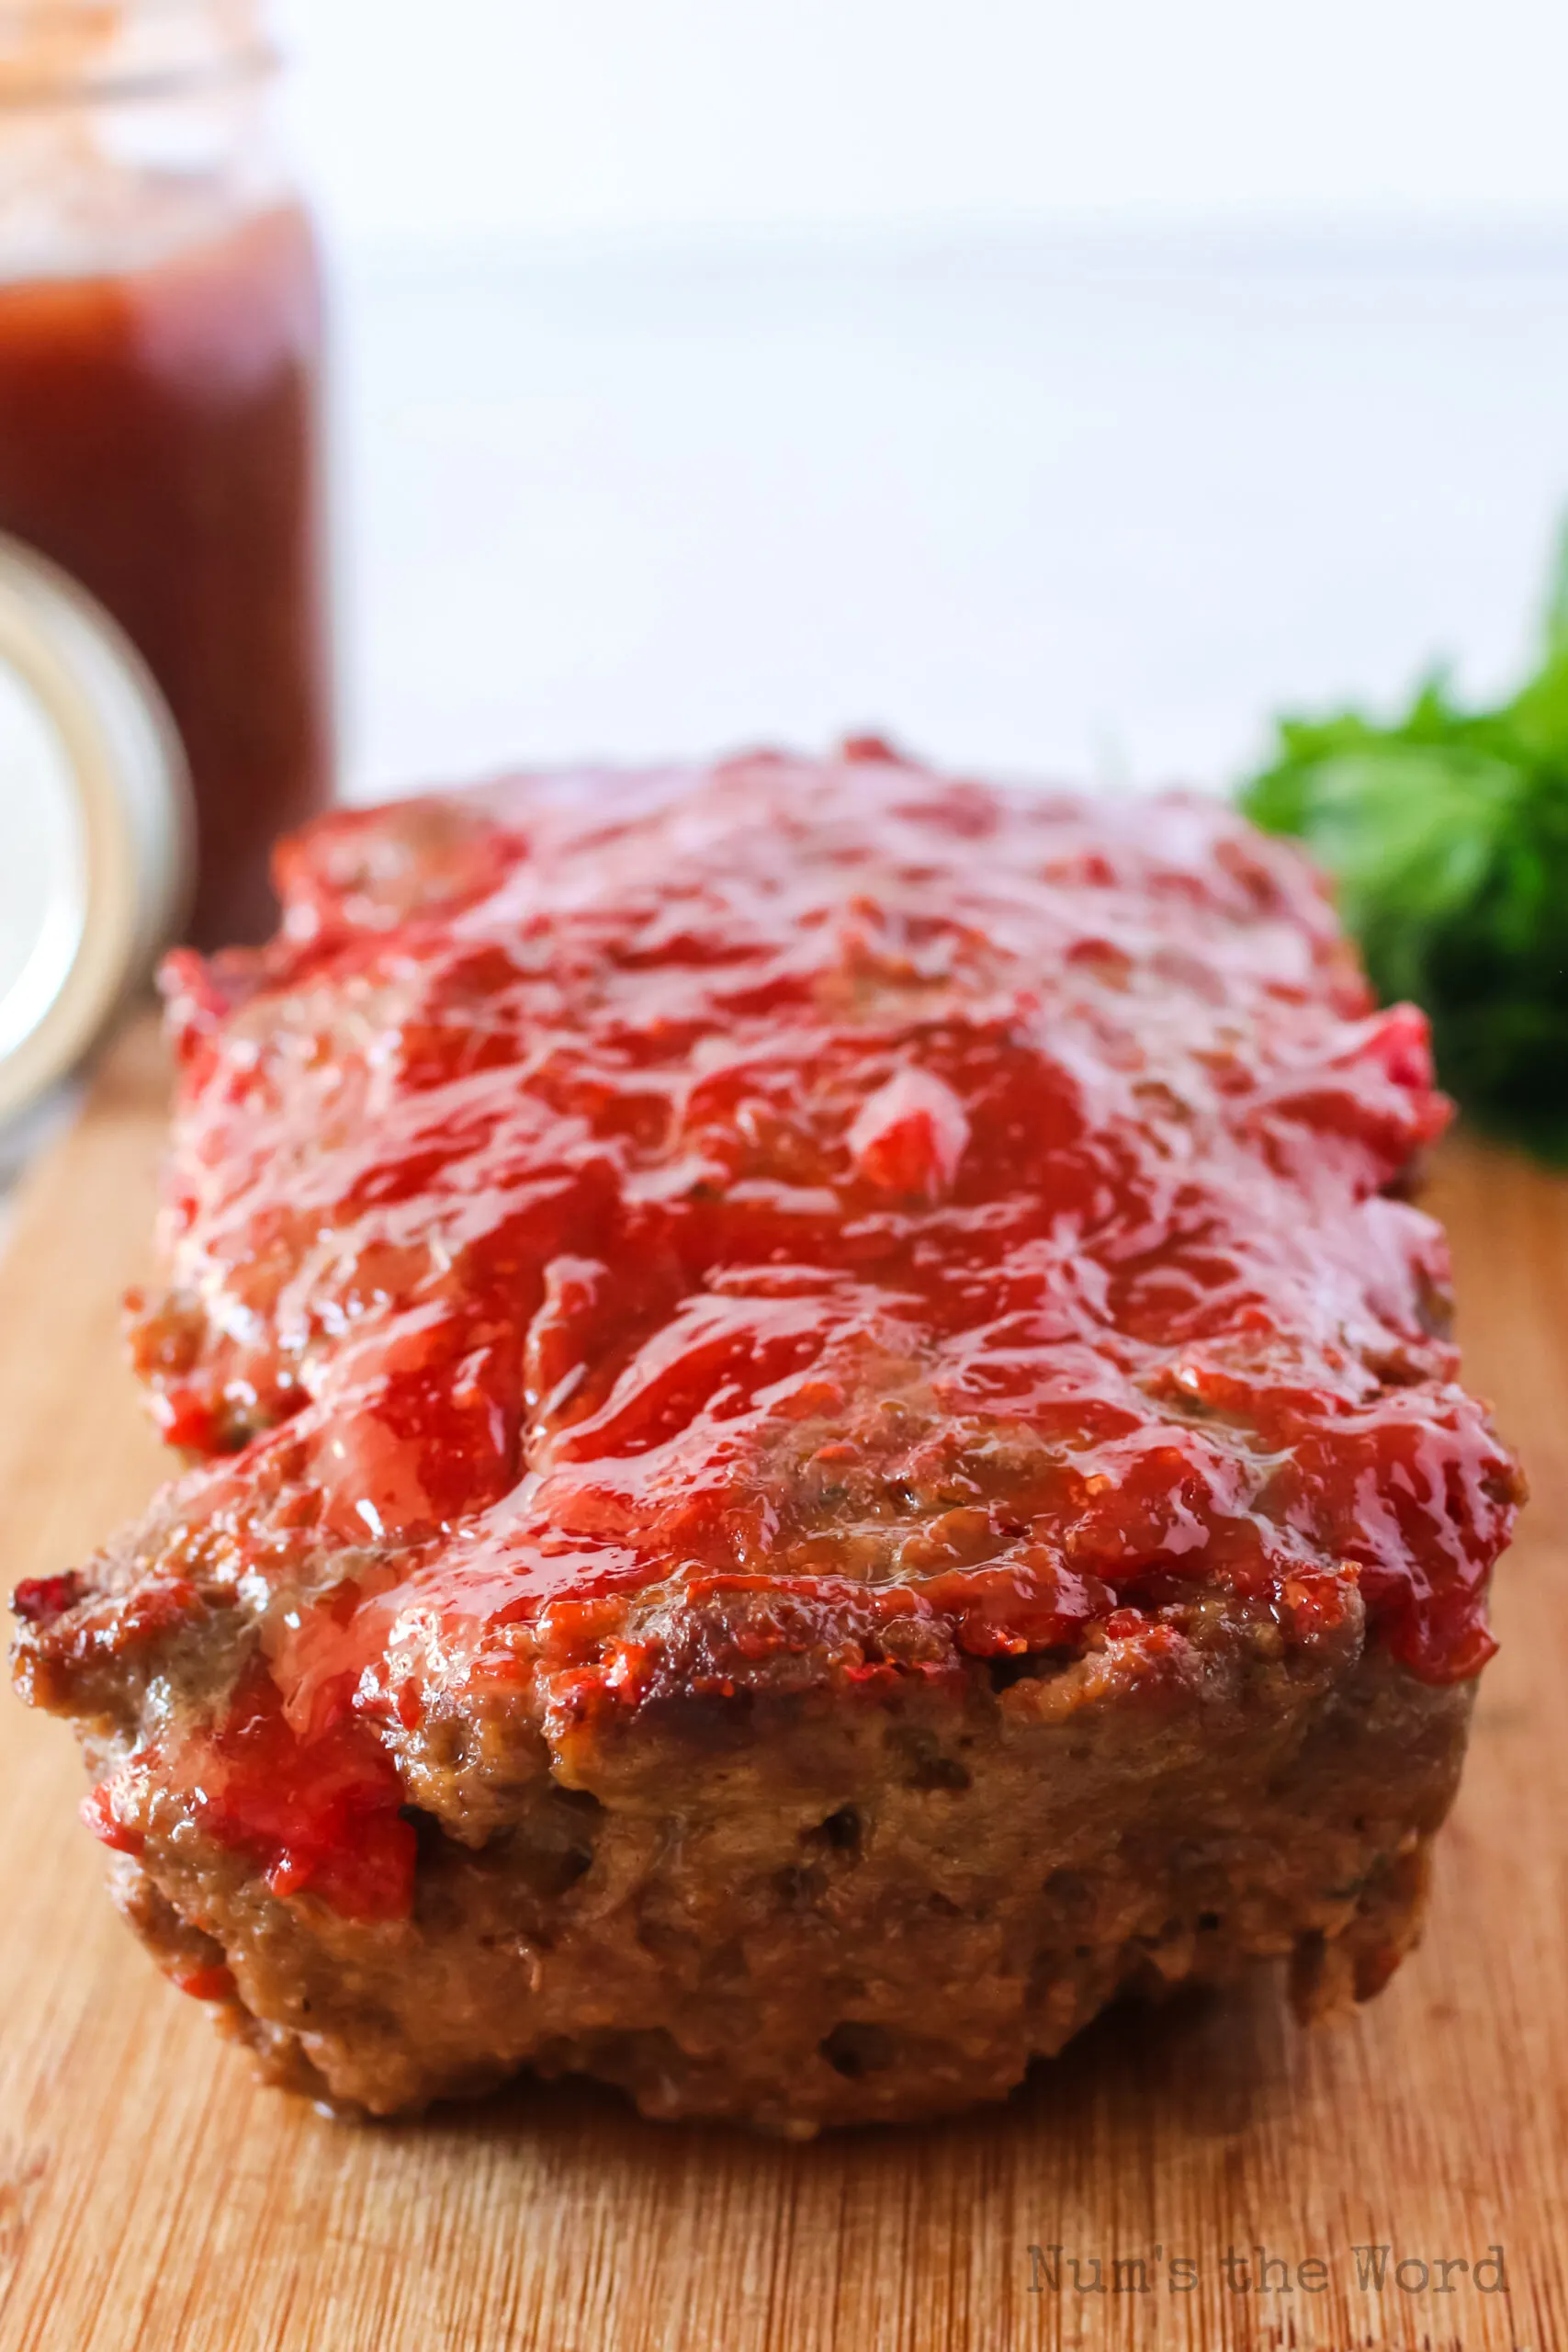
136;746;1514;1900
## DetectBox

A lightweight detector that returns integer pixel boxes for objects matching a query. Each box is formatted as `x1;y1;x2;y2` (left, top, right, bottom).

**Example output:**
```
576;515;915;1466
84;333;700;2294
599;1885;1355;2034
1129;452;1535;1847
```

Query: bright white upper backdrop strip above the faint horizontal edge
289;0;1568;235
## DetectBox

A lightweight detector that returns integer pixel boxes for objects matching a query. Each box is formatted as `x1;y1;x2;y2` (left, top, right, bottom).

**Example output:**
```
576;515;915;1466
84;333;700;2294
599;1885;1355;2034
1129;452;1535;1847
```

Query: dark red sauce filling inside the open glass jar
0;205;332;945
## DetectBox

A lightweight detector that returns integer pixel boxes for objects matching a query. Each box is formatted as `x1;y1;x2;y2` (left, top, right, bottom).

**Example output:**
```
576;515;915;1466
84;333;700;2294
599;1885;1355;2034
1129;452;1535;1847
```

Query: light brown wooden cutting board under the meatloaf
0;1023;1568;2352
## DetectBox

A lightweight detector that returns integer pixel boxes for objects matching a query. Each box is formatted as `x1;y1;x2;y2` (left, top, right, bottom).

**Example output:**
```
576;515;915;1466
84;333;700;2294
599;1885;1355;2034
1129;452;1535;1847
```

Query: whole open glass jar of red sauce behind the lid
0;0;333;945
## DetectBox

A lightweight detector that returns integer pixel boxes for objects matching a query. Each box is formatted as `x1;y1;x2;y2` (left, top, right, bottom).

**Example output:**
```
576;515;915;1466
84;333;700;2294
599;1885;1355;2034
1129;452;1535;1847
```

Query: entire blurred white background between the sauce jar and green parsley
272;0;1568;793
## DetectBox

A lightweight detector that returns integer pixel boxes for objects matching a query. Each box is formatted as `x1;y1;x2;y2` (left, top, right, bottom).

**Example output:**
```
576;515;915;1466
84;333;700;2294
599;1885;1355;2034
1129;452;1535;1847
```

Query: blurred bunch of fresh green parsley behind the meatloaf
1241;532;1568;1162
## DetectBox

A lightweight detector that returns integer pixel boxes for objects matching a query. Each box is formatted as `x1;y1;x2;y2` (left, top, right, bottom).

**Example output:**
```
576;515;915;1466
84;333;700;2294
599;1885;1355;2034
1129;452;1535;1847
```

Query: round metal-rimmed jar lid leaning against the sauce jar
0;537;195;1120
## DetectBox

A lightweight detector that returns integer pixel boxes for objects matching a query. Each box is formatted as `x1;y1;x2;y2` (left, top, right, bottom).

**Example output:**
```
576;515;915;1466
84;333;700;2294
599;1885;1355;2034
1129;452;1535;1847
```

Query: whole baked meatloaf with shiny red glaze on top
17;743;1517;2133
